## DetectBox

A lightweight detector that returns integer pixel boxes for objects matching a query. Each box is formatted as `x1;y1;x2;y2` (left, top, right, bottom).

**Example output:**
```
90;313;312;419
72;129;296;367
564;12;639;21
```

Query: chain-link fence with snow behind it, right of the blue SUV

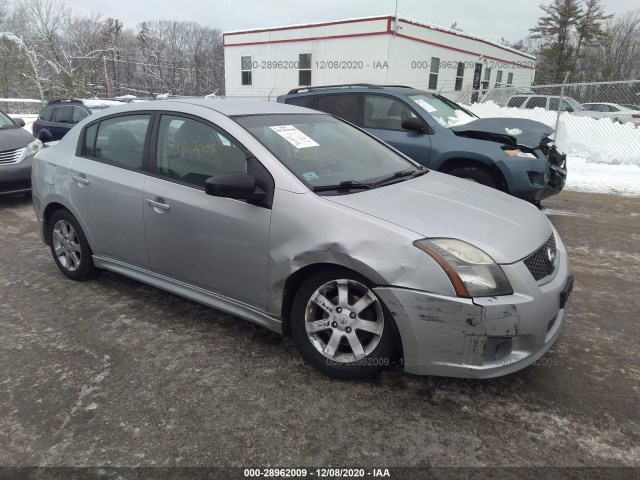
440;80;640;165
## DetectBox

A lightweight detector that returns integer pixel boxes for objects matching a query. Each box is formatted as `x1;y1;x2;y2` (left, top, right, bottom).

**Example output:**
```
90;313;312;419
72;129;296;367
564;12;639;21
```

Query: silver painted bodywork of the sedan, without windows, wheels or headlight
32;100;569;377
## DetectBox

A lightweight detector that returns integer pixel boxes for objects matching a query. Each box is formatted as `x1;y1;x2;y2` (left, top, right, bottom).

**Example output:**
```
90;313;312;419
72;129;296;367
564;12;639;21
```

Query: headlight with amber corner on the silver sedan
413;238;513;297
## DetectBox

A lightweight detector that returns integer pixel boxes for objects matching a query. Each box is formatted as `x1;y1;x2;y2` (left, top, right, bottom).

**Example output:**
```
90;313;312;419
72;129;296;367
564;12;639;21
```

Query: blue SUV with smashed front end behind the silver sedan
278;84;567;204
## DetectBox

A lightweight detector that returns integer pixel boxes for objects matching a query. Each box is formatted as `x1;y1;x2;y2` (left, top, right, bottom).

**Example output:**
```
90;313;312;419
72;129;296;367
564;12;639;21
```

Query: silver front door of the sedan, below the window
141;176;271;310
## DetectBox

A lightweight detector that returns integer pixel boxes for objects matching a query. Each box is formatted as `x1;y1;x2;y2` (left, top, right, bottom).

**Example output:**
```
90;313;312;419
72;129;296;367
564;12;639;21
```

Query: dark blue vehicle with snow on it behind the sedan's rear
33;100;122;142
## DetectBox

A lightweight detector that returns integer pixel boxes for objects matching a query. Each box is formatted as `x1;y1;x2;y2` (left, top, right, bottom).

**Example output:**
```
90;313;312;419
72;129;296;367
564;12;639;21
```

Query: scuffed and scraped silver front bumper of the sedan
375;246;573;378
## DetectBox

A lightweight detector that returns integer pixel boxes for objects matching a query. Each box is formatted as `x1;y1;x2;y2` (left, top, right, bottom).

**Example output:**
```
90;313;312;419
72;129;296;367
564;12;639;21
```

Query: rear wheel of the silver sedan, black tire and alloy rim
47;210;98;280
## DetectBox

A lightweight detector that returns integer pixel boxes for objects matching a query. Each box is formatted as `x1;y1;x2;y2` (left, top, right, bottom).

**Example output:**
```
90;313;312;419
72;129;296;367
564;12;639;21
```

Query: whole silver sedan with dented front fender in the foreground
32;100;573;378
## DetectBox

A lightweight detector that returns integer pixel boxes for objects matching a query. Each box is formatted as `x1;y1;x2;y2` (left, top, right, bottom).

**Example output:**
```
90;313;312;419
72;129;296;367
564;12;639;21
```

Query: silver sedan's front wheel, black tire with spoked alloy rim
291;268;397;379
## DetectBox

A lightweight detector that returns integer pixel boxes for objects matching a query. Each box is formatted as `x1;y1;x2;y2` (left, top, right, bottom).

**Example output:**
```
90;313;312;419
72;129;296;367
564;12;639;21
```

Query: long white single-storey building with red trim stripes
223;16;536;100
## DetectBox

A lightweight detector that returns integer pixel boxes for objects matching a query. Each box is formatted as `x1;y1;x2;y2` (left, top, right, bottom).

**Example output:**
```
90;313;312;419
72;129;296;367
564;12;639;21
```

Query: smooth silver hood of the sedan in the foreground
325;171;552;264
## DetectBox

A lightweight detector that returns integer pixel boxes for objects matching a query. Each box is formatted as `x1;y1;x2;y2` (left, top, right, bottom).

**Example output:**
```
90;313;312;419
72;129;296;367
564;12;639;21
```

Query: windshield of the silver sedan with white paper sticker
234;114;423;189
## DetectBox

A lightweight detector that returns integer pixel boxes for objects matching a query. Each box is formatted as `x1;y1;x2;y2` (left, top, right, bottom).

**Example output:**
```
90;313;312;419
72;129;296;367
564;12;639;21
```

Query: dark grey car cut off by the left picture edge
0;111;42;195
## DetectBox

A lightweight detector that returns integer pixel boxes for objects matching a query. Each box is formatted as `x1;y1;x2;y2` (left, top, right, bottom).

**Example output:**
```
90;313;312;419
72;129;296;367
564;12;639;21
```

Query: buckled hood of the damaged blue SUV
450;118;554;148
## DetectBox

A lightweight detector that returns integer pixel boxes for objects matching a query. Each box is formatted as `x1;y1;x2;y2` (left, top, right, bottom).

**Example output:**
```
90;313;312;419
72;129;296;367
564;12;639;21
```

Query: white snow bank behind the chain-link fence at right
465;101;640;166
